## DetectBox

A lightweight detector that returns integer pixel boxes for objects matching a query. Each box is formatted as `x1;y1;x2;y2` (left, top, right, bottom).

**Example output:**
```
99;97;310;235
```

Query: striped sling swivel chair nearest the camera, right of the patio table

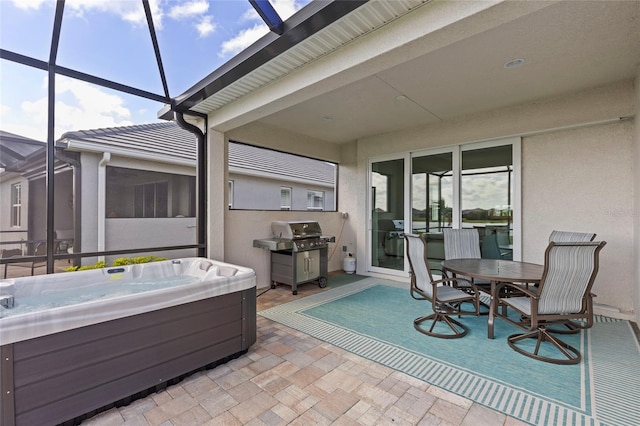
495;241;606;364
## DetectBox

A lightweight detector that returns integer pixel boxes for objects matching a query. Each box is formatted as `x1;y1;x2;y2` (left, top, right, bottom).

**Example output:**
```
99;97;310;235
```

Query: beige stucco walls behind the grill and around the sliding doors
216;81;638;316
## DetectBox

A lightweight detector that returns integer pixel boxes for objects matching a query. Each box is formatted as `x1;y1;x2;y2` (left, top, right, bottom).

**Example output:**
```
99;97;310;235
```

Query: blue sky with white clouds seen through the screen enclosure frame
0;0;310;140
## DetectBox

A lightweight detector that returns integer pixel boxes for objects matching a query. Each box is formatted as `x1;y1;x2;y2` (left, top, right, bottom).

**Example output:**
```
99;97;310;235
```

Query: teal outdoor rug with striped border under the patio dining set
259;278;640;426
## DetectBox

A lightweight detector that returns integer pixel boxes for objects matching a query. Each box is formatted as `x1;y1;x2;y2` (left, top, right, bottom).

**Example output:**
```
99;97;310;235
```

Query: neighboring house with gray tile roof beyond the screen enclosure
0;122;336;263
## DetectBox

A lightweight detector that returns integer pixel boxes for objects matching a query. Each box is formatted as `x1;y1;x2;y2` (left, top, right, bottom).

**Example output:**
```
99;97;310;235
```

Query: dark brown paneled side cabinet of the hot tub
0;287;256;426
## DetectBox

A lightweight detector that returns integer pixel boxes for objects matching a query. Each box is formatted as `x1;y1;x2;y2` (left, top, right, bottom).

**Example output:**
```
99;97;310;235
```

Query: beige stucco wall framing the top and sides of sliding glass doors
356;81;638;313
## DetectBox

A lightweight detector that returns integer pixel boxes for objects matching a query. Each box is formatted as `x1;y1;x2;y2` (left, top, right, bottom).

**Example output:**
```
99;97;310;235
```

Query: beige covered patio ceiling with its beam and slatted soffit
168;0;640;143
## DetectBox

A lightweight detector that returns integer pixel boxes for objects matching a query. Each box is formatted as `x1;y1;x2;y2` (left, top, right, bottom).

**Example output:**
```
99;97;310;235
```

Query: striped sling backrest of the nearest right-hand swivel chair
537;241;606;315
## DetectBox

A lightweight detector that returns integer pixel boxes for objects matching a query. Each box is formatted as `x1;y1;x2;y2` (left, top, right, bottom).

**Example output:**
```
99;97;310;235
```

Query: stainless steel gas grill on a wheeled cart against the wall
253;221;335;294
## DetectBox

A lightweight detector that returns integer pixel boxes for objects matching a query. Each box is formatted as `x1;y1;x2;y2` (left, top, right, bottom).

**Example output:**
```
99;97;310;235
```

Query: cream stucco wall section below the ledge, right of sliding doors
522;121;635;312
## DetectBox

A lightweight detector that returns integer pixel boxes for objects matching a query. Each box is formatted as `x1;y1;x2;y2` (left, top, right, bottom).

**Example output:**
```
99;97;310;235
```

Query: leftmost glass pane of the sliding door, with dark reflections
370;159;405;271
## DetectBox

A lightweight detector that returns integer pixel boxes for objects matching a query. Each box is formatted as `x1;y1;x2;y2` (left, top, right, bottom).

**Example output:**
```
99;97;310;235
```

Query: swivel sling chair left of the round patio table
404;234;479;339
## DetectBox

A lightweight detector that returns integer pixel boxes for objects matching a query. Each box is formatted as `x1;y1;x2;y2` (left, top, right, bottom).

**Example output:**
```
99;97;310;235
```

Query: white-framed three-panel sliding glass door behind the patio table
369;138;521;273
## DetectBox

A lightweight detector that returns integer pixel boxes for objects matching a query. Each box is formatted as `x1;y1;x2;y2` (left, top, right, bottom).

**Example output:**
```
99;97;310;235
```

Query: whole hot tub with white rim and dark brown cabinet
0;258;256;426
